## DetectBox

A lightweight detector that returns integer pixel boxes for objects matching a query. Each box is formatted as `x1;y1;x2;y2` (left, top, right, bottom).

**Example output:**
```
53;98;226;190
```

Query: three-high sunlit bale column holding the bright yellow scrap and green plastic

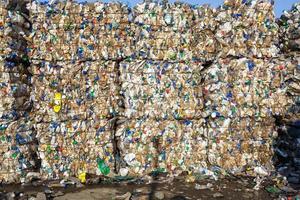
28;1;131;179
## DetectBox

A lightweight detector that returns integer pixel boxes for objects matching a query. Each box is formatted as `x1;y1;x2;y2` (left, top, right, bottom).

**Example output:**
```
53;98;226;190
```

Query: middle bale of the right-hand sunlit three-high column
203;58;288;119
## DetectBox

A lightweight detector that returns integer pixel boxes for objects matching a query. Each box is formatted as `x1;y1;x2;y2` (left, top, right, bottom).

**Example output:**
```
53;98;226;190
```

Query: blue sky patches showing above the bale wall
72;0;300;17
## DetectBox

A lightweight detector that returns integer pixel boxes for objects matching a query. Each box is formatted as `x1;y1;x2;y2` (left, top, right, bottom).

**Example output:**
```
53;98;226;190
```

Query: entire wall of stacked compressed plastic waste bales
0;0;300;182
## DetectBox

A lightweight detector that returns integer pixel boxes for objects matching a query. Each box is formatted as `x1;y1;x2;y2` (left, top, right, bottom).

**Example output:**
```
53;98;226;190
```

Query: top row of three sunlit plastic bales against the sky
27;0;279;62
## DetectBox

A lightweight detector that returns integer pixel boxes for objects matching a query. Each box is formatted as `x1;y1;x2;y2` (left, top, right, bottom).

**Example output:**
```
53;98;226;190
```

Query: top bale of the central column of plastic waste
132;2;195;61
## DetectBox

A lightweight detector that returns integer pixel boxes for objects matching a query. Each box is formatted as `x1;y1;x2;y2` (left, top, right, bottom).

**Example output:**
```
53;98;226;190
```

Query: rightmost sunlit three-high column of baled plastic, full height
203;0;288;175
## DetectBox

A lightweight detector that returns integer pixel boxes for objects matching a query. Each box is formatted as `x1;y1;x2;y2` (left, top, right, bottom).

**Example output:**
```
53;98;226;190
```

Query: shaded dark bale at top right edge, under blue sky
278;3;300;52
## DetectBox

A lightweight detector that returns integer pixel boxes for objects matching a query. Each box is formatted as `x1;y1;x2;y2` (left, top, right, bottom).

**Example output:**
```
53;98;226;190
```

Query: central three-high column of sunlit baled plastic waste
116;2;207;175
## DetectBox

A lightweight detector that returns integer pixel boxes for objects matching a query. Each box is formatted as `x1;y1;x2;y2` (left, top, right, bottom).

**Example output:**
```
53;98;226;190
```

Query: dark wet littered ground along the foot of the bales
0;177;300;200
